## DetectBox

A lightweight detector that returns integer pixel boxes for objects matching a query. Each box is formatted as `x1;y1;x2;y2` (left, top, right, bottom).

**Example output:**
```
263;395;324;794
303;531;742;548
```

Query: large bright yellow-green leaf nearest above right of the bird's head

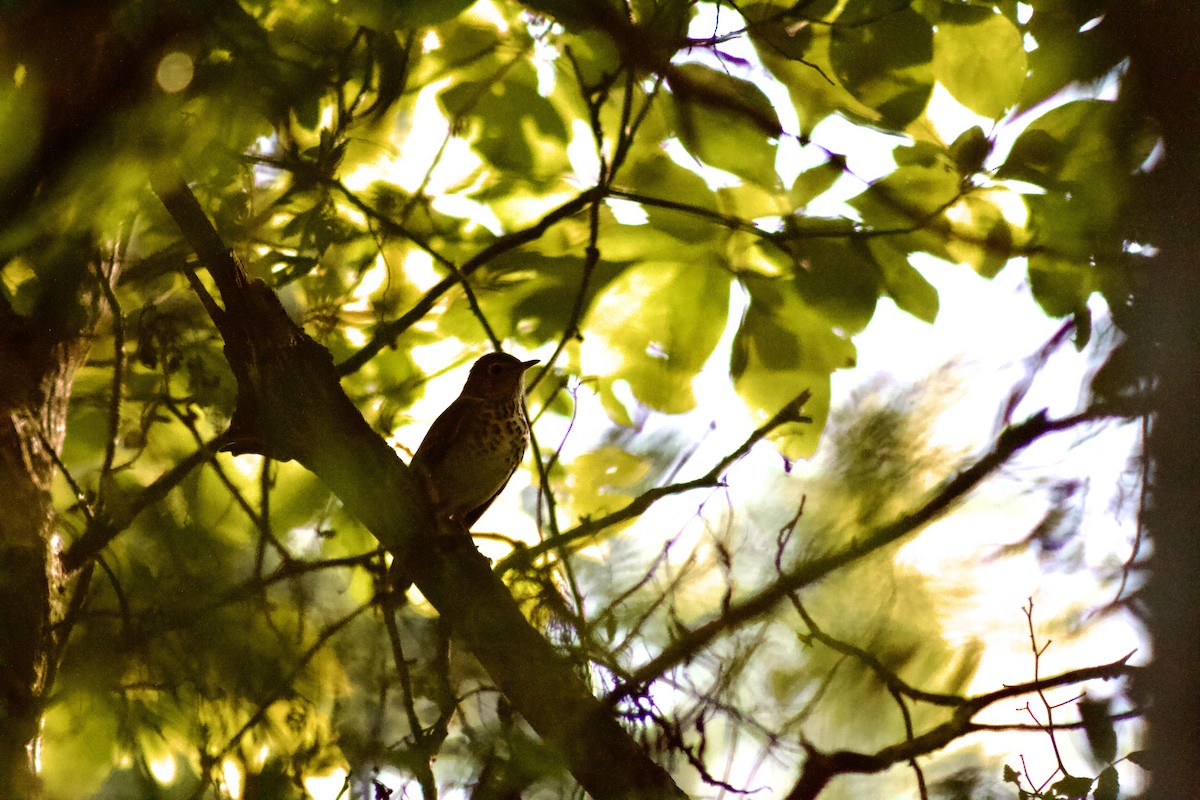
584;261;730;419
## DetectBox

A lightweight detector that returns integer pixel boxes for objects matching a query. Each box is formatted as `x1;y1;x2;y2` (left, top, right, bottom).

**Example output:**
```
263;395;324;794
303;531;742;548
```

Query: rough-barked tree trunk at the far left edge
0;246;112;799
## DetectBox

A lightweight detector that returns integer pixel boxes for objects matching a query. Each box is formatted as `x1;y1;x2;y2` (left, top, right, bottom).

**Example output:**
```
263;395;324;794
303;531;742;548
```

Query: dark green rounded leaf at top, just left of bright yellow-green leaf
829;0;934;130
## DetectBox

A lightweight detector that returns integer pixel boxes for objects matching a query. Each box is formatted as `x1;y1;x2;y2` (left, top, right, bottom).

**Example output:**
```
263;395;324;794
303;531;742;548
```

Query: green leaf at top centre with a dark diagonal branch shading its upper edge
667;64;781;187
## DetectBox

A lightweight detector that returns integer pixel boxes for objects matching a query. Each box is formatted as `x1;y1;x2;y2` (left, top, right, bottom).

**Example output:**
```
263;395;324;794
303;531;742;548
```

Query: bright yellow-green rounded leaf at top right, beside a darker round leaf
934;4;1025;119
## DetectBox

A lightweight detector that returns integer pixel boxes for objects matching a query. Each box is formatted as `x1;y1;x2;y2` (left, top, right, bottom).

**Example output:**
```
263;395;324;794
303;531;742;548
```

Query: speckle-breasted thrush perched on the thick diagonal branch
412;353;538;530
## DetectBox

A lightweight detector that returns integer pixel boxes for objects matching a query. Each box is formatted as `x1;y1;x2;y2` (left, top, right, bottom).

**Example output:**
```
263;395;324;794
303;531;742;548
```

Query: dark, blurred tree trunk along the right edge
1114;0;1200;800
